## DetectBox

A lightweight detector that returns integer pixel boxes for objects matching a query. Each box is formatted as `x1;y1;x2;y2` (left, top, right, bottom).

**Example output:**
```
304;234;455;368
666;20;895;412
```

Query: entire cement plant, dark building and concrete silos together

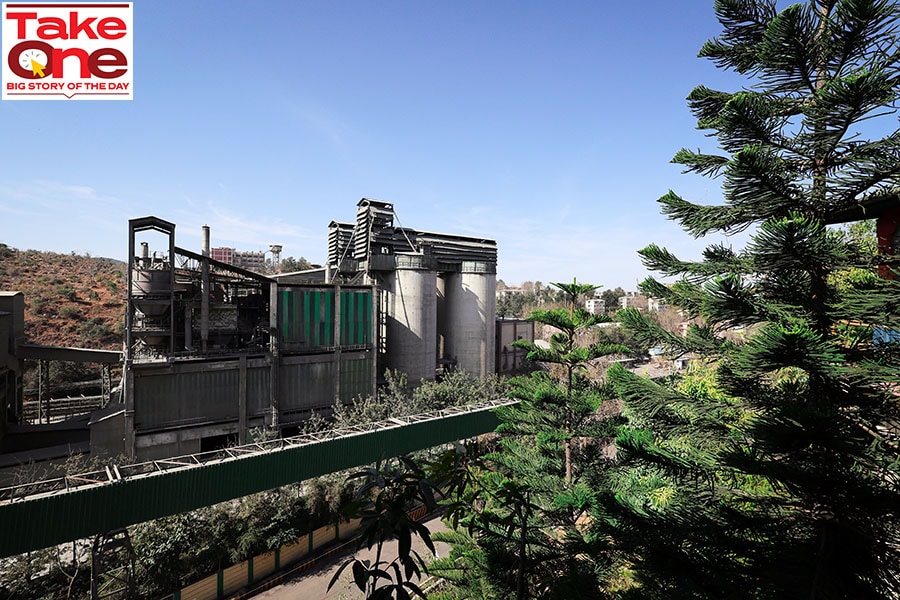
0;198;533;460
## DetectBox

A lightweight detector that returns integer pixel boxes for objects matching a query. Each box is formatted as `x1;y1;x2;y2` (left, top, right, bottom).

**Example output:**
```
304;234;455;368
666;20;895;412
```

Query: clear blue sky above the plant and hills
0;0;741;288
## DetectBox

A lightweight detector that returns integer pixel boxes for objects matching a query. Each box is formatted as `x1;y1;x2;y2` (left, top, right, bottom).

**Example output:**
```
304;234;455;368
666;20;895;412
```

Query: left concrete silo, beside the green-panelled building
384;254;437;384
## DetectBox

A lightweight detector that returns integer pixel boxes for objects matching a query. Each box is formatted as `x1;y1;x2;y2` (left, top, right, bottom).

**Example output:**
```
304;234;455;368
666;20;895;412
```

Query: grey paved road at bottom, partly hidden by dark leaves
253;516;450;600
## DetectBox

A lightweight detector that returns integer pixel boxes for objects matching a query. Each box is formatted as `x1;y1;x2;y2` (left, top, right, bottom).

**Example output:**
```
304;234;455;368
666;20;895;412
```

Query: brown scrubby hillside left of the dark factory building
0;243;126;350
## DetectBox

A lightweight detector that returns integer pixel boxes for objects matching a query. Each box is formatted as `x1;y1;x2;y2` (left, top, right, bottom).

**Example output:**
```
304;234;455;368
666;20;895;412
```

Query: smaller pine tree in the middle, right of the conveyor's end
429;281;629;600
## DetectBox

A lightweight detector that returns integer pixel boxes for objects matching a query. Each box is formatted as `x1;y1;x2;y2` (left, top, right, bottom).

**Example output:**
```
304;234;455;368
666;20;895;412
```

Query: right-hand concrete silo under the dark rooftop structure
444;262;497;376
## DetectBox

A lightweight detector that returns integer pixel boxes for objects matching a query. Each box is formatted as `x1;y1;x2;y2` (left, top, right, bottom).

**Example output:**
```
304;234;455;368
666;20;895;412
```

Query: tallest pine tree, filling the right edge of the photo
602;0;900;599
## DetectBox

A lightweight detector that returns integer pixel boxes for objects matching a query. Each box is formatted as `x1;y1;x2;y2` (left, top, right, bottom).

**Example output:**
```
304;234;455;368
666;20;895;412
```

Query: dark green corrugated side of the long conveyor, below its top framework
0;411;497;557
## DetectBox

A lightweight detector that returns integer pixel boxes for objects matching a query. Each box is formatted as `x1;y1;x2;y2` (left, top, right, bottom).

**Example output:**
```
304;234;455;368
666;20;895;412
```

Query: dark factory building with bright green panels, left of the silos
110;217;376;459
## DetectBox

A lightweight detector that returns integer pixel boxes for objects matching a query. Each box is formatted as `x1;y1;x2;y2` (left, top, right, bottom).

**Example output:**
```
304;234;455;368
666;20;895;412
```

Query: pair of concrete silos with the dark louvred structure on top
327;198;497;381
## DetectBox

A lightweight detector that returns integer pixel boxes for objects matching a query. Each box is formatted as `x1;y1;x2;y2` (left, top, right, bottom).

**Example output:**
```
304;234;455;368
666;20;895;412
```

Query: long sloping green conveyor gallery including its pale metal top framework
0;400;514;558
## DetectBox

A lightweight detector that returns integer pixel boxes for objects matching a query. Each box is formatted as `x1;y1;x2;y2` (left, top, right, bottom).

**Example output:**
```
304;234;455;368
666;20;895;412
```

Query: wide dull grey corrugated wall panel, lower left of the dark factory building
134;368;240;429
